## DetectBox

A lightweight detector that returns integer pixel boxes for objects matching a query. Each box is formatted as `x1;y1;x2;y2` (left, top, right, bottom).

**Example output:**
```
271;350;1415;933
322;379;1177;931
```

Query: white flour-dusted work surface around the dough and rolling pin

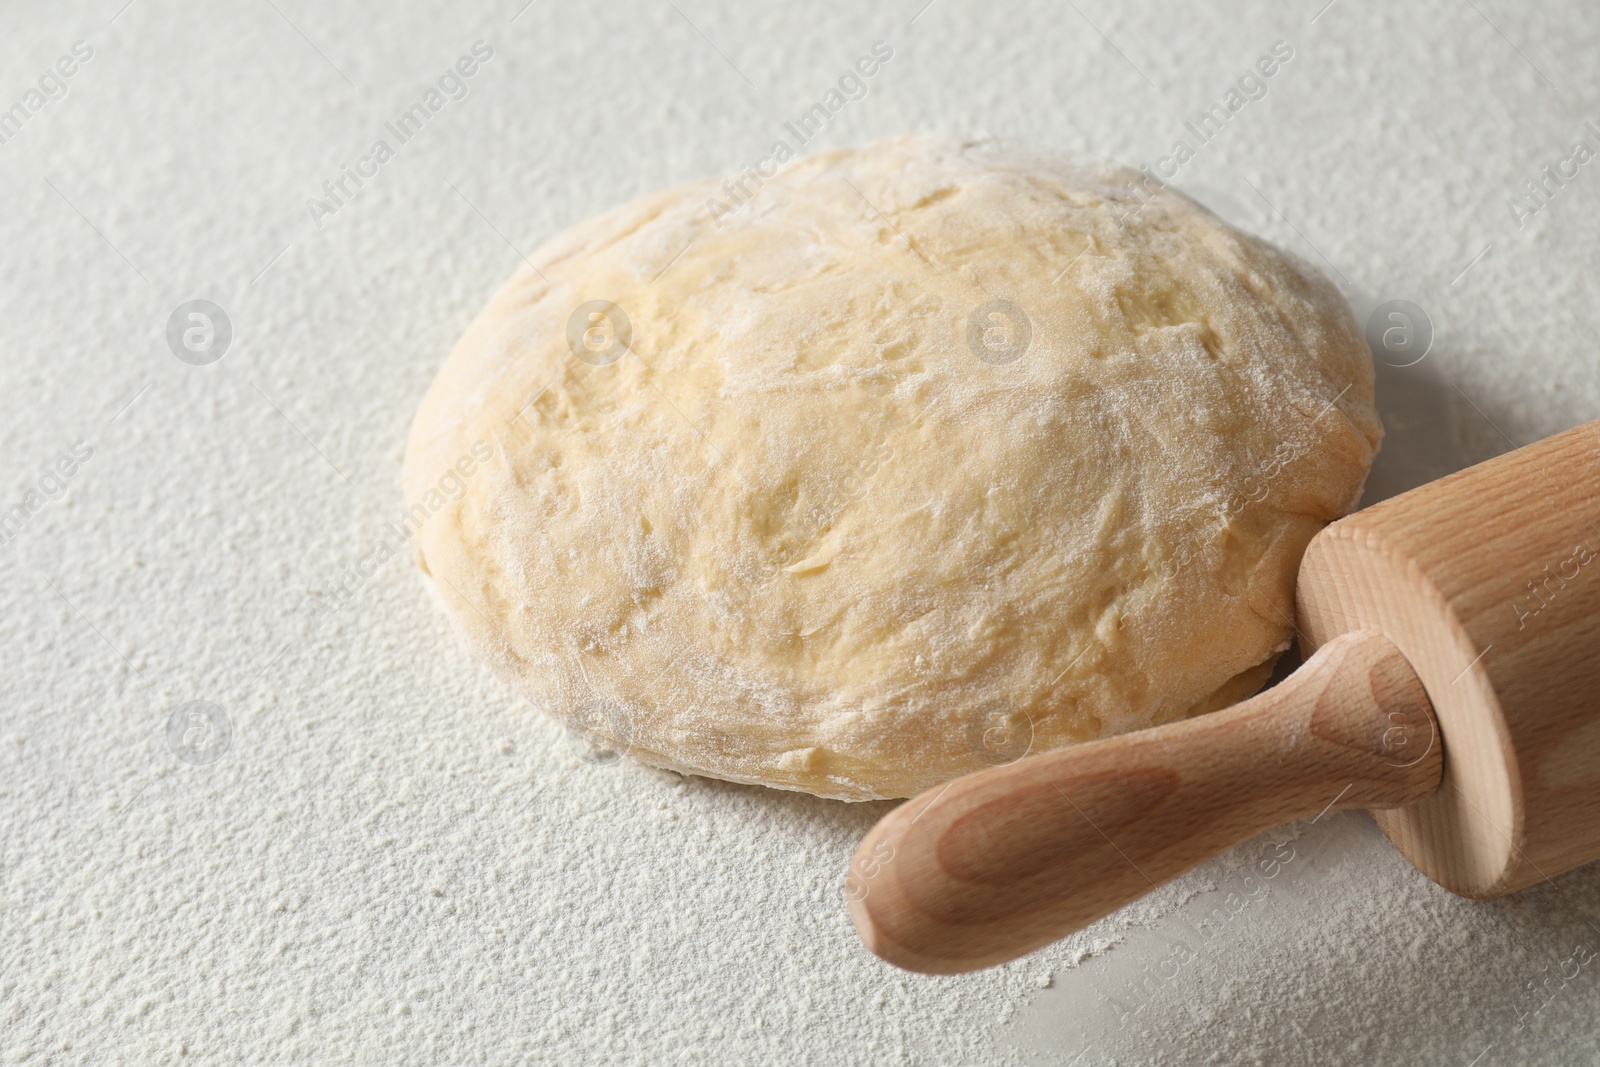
0;0;1600;1067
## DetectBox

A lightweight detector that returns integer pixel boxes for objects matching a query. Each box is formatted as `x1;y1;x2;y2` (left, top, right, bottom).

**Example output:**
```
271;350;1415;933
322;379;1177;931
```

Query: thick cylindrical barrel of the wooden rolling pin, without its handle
1298;412;1600;897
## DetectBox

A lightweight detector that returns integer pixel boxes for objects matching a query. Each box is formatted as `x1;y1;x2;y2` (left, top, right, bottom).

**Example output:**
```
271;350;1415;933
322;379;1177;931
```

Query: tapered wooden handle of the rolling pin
846;632;1442;974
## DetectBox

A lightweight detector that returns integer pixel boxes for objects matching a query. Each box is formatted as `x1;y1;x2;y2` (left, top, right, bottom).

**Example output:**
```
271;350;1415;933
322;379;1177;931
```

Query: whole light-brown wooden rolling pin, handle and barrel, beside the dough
845;421;1600;974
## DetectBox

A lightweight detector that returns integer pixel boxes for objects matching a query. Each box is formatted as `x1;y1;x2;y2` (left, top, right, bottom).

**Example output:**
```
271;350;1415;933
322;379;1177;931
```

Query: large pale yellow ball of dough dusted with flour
406;136;1382;800
